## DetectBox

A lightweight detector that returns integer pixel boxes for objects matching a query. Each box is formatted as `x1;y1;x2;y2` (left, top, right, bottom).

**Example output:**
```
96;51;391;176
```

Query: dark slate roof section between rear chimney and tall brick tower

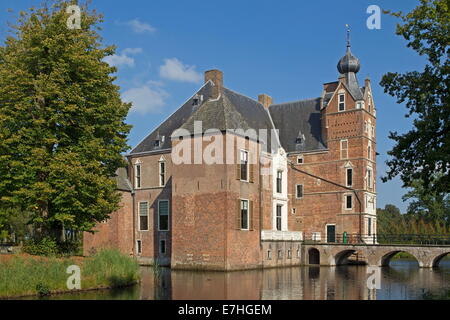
269;98;326;152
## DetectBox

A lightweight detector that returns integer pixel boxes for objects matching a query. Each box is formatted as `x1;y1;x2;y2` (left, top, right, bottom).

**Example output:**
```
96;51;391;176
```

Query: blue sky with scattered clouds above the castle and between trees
0;0;424;211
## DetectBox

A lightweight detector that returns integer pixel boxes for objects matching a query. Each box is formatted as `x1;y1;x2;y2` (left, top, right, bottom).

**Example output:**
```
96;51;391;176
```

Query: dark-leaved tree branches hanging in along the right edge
381;0;450;192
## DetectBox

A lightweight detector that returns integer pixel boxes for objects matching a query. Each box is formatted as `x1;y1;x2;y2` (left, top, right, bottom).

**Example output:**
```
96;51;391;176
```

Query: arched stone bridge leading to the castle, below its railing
302;243;450;268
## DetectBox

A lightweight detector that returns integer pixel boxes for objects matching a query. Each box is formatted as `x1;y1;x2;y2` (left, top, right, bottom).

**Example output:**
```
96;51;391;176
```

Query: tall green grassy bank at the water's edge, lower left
0;250;139;299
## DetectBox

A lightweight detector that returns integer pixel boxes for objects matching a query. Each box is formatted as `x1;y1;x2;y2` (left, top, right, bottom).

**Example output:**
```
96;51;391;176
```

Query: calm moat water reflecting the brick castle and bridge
37;258;450;300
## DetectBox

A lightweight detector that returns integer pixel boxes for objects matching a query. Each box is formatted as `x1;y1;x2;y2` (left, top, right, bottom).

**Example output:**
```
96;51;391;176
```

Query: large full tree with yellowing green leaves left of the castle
0;0;130;238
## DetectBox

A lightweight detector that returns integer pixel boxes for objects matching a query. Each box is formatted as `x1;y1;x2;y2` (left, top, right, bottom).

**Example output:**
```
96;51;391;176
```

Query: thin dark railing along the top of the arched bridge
303;233;450;246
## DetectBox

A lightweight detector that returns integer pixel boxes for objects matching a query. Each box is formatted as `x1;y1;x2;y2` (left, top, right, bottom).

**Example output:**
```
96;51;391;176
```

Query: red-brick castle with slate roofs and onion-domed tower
83;42;377;270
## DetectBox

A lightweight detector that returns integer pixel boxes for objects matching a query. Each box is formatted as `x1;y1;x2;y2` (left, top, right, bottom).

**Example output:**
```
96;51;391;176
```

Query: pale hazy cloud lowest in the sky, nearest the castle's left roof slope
122;83;169;114
